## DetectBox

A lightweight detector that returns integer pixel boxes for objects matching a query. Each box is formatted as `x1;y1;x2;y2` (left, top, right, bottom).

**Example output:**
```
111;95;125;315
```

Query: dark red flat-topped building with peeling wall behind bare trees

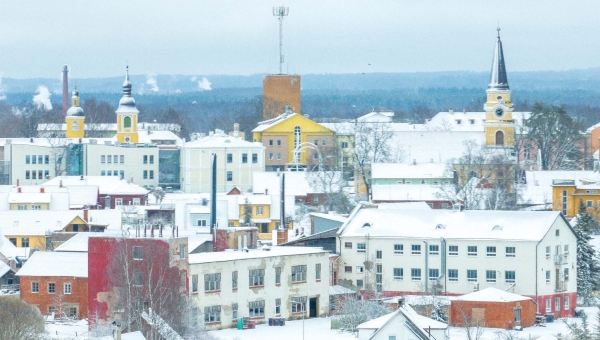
88;234;188;331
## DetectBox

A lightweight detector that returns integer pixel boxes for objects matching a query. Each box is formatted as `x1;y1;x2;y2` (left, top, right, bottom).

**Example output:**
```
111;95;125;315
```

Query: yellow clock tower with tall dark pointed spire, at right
483;28;515;148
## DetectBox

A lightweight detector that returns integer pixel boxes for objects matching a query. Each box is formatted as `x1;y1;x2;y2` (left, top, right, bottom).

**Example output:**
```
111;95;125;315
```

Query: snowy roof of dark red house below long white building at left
44;176;148;195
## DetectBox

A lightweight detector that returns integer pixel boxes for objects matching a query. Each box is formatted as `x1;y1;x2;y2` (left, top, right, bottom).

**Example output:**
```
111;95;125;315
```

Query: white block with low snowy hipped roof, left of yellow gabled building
180;130;265;192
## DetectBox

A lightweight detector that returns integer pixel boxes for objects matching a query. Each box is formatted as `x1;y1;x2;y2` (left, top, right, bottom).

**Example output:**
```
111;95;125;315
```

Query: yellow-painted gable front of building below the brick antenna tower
252;114;334;164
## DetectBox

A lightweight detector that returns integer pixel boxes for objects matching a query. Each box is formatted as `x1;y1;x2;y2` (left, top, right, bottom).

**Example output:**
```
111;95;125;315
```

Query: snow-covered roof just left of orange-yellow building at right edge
518;171;593;205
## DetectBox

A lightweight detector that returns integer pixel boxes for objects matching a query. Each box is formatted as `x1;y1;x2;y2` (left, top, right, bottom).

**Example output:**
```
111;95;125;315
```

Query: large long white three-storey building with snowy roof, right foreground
337;203;577;317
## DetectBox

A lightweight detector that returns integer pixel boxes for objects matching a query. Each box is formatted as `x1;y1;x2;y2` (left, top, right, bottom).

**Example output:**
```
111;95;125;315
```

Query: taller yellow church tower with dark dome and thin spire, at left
116;66;140;143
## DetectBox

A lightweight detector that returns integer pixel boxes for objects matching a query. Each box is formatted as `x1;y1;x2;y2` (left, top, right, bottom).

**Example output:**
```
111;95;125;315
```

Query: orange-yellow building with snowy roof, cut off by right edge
552;173;600;220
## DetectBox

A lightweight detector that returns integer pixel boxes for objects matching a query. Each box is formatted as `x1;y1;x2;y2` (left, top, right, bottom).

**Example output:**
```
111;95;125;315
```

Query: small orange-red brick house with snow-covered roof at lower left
17;251;88;319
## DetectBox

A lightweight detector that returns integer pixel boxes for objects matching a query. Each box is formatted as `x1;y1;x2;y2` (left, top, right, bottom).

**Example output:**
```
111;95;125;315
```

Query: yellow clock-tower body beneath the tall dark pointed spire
483;89;515;148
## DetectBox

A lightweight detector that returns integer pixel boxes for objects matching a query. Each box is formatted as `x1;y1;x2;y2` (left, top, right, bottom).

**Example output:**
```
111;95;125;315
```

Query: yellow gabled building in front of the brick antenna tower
252;107;337;171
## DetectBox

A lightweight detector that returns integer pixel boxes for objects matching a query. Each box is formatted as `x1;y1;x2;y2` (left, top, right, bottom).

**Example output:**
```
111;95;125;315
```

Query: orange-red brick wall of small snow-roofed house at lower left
21;276;88;319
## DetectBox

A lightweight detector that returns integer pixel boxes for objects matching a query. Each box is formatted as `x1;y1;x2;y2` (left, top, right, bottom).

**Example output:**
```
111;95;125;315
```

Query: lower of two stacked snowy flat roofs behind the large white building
371;184;448;201
